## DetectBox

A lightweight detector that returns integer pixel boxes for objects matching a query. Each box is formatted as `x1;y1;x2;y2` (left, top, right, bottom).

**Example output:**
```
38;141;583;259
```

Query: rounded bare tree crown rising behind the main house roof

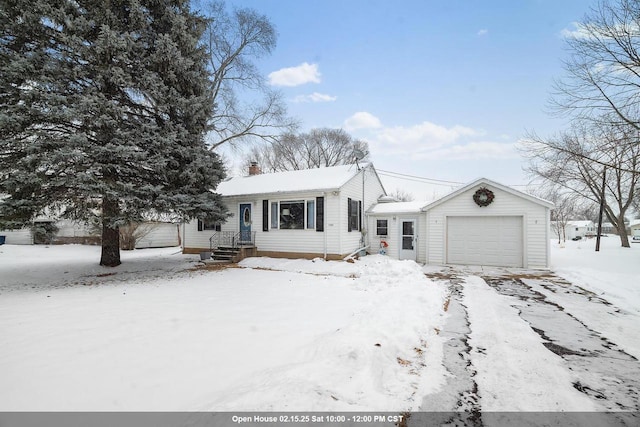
246;128;368;172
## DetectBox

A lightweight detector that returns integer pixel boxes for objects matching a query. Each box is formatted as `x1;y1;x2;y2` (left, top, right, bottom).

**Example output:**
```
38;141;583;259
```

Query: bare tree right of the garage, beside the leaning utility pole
523;123;640;247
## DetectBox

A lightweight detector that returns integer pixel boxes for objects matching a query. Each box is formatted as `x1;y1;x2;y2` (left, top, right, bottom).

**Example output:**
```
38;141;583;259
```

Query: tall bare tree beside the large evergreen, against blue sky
204;1;295;150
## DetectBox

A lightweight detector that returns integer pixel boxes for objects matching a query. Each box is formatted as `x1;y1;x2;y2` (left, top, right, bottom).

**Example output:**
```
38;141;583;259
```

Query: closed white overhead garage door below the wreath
447;216;523;267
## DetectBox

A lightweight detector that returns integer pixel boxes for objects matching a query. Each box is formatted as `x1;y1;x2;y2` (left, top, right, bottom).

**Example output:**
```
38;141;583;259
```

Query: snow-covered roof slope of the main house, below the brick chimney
216;165;358;196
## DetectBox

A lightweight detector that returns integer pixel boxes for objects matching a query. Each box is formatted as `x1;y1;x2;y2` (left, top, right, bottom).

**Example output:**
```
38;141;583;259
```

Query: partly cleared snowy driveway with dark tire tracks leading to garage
421;267;640;426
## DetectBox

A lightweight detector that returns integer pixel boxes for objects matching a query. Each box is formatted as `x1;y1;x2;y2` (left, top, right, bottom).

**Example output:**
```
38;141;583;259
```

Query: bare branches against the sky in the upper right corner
552;0;640;129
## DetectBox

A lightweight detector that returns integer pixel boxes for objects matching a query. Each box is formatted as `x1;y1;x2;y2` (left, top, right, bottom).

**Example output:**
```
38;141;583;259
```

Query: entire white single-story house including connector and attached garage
183;165;553;268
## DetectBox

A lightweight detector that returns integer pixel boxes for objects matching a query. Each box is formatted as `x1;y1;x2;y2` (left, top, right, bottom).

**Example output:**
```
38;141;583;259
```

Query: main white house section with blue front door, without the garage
183;165;386;259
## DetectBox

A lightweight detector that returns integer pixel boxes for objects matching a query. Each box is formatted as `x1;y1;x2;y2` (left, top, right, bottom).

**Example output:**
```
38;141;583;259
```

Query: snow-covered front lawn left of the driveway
0;245;446;411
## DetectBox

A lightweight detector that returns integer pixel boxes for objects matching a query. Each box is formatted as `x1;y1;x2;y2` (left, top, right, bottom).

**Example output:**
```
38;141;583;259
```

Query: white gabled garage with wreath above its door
422;178;553;268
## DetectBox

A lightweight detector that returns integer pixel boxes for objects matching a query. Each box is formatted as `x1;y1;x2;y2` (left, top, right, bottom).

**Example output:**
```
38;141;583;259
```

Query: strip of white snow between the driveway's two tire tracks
464;276;599;412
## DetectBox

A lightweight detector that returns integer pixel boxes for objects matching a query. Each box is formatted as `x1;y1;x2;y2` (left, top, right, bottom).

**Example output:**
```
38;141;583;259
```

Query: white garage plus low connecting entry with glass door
368;178;553;268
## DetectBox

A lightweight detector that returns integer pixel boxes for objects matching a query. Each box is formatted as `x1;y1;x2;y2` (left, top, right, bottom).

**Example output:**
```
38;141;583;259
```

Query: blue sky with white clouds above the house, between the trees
221;0;595;199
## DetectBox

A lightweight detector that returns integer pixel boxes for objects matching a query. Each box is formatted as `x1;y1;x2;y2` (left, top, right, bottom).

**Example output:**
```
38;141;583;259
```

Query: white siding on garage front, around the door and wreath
426;185;549;268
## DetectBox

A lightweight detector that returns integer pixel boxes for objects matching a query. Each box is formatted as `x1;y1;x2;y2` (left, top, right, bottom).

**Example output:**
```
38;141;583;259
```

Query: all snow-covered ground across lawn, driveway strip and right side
0;236;640;411
